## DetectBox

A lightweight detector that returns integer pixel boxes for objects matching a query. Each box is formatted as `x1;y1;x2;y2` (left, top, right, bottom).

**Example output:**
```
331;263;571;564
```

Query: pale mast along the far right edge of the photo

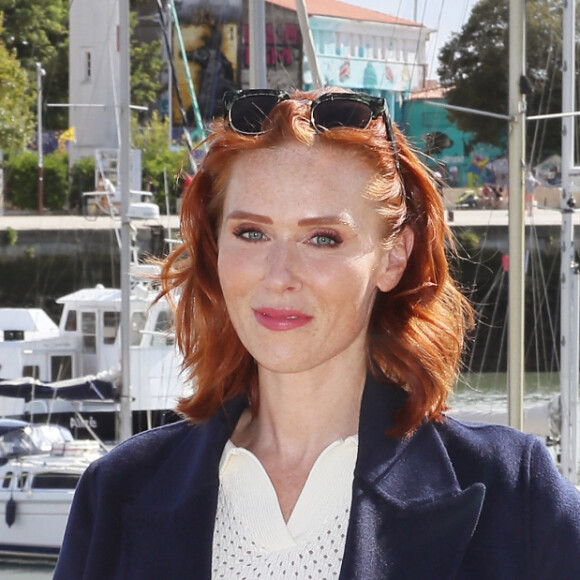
560;1;580;484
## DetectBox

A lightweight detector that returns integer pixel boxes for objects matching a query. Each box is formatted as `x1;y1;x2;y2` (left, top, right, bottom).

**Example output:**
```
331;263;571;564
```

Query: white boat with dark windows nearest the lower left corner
0;419;105;561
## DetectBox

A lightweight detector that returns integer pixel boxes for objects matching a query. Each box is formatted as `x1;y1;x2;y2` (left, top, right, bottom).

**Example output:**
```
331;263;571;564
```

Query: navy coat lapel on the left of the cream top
121;398;247;580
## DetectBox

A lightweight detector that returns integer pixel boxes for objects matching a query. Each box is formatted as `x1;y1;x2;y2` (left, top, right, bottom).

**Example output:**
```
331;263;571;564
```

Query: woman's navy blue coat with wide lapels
54;380;580;580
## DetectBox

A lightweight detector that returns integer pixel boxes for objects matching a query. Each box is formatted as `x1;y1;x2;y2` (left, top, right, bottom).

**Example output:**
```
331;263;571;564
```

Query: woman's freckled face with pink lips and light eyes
218;144;396;373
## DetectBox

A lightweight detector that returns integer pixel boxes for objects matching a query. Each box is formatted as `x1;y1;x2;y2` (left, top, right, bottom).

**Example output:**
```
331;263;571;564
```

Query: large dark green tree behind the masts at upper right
438;0;563;161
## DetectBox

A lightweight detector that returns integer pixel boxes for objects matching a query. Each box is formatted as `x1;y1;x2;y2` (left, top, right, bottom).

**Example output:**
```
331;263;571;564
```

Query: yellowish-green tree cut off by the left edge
0;19;34;151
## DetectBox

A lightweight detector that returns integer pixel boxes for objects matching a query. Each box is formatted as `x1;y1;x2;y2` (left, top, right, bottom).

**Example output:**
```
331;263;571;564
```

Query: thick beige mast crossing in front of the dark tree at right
508;0;526;430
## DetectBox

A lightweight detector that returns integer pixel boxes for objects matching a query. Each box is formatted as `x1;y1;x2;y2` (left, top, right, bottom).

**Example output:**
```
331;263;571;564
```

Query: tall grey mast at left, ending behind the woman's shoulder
118;0;133;441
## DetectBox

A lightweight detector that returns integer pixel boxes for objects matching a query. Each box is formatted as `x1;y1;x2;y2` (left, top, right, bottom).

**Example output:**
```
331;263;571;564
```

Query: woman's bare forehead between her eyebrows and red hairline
224;143;375;214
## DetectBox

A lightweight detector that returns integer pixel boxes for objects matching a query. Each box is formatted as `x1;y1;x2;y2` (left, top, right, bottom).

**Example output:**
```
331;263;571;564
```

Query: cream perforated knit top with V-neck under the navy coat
212;435;358;580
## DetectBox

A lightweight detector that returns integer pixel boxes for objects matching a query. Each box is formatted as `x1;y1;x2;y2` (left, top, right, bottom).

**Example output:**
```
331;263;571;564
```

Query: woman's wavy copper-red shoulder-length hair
160;89;473;435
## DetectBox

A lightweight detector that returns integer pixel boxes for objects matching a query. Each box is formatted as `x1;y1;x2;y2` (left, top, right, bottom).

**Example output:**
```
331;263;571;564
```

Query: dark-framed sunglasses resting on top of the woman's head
224;89;400;173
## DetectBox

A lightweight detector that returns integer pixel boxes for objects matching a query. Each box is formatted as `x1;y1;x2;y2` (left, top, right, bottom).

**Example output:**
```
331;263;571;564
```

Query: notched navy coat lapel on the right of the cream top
340;379;485;580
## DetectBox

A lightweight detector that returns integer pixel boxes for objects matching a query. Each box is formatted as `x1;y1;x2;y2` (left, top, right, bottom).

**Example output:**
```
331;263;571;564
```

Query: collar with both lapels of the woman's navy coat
123;378;485;580
